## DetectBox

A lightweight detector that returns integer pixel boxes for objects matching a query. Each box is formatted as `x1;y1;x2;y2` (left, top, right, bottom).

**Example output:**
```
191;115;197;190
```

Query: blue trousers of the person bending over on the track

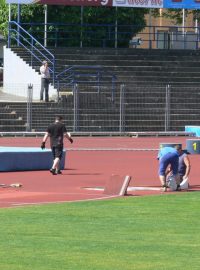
159;153;179;176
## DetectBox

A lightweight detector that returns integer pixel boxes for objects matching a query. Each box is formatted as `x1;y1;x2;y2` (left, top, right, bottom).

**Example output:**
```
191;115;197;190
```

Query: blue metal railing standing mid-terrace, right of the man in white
56;65;117;101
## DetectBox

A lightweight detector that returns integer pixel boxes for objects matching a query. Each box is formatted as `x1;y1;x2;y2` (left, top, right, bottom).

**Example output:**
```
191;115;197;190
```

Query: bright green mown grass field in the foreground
0;192;200;270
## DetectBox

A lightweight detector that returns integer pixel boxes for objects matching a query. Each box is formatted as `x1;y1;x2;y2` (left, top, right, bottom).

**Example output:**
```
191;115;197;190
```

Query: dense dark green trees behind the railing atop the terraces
0;0;148;47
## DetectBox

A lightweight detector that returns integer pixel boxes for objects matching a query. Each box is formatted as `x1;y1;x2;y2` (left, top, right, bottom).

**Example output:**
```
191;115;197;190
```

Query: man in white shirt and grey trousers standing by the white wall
40;60;50;102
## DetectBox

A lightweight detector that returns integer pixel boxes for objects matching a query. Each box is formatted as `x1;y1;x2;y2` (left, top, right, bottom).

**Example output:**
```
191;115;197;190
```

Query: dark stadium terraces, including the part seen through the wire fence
1;48;200;131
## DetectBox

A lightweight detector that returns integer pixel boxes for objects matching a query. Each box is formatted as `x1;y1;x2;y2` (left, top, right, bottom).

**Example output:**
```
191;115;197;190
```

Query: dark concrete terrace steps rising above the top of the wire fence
9;47;200;86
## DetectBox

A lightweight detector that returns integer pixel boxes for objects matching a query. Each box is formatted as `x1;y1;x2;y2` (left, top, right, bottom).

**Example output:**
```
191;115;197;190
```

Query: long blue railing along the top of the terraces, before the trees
17;23;200;50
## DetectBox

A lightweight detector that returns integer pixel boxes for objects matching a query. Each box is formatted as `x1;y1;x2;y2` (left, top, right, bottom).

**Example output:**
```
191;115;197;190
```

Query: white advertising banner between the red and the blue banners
113;0;163;8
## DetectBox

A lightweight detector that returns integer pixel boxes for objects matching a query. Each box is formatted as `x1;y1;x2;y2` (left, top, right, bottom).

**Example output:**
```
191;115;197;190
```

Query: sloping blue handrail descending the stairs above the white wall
8;21;55;85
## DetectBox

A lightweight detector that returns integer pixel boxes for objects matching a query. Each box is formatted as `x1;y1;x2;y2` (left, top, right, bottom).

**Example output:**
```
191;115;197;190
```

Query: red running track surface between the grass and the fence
0;137;200;207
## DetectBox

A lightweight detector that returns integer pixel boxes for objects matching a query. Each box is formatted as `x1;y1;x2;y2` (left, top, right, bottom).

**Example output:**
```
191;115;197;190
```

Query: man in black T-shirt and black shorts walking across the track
41;116;73;175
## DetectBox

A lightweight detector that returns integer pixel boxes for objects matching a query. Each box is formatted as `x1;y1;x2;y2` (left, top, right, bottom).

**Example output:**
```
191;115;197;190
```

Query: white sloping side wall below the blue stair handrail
3;46;57;100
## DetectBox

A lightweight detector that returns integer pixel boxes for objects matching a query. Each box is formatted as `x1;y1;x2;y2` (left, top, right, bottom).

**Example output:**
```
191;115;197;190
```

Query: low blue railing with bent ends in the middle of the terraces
56;65;117;101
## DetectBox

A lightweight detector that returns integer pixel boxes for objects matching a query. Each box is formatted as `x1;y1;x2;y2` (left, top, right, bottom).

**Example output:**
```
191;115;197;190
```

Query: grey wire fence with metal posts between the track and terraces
0;84;200;134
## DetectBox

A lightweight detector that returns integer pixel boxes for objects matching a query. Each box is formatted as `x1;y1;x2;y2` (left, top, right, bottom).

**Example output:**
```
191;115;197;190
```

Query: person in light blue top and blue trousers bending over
158;145;181;192
